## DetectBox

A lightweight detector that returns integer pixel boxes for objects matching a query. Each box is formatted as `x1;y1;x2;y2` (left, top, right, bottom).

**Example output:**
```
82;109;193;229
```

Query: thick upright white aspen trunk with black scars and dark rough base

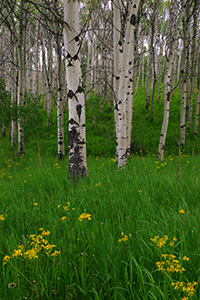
63;0;87;180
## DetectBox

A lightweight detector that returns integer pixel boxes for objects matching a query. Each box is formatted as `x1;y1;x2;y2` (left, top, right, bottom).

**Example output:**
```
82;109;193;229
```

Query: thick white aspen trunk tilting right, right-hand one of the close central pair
117;1;139;168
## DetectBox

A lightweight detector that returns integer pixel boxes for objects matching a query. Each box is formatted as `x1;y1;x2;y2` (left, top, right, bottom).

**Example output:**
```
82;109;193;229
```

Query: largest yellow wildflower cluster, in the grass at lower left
3;228;61;265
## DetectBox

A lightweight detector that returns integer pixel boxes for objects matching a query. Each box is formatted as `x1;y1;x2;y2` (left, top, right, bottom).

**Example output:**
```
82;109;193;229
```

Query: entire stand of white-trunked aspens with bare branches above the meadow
0;0;200;176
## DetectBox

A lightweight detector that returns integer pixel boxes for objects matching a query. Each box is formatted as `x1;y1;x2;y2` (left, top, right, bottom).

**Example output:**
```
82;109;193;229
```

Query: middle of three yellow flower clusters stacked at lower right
156;254;185;274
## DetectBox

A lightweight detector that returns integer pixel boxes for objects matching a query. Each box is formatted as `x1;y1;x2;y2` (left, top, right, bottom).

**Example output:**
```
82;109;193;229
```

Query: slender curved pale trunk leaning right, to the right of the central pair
158;4;185;160
